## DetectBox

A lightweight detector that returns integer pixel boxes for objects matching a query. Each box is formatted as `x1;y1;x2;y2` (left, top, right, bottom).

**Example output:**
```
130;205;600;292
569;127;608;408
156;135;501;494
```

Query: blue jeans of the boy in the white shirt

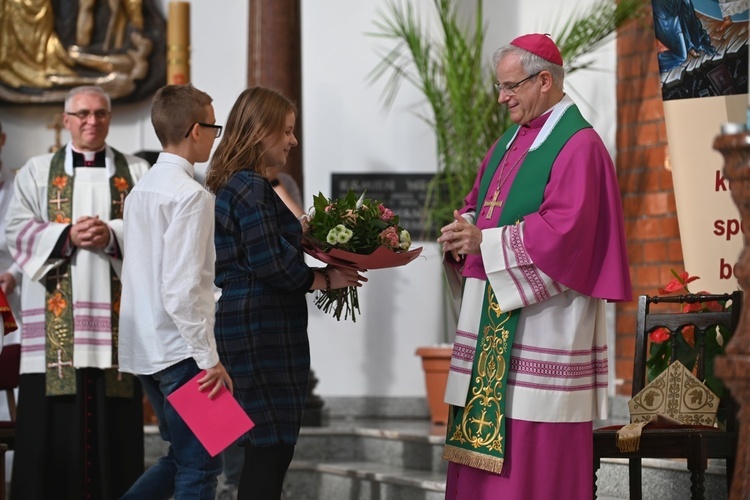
122;358;222;500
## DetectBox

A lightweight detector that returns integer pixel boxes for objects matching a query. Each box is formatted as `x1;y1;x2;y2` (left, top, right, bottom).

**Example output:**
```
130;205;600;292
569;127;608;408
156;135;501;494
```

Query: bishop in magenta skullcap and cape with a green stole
438;34;631;500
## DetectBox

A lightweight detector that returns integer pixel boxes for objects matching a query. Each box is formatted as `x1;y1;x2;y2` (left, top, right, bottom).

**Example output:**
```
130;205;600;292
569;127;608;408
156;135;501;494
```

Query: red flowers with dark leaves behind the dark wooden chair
646;271;732;398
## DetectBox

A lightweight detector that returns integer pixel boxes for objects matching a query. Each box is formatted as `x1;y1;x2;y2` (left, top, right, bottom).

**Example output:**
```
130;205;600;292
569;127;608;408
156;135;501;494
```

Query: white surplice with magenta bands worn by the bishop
445;219;607;422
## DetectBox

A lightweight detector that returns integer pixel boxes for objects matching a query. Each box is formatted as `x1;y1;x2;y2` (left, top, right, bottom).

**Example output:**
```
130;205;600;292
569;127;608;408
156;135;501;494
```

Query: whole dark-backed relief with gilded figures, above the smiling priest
0;0;166;103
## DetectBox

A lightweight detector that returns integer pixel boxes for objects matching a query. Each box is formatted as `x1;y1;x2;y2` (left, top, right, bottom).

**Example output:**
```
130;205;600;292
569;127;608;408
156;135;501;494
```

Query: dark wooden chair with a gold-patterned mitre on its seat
594;291;742;500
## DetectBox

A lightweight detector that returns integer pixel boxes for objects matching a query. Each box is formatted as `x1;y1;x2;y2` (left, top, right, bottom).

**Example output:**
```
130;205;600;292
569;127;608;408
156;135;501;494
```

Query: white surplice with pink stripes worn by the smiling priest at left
5;144;149;373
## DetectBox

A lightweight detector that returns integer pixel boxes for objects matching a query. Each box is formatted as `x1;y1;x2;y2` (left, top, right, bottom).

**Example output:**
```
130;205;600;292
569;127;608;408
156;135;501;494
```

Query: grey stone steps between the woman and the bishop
284;419;447;500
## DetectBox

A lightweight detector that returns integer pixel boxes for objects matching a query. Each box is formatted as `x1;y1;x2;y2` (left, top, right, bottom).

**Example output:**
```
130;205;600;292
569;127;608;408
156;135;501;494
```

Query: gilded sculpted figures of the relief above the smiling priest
0;0;153;102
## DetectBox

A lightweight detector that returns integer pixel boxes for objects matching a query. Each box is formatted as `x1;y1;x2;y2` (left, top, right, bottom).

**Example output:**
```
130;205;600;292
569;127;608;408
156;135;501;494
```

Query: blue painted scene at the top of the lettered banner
651;0;748;101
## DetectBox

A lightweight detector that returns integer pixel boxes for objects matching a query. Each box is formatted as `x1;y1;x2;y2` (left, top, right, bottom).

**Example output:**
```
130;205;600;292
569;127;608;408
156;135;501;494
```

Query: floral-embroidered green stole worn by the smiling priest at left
44;148;133;397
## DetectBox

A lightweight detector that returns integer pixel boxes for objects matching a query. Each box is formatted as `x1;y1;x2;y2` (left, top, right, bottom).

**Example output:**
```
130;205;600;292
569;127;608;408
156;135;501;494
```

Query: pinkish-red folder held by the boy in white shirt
167;370;255;457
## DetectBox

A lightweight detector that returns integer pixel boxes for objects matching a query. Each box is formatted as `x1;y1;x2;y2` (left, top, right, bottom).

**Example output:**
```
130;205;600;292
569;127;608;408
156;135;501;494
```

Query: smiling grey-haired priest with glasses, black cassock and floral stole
6;87;148;499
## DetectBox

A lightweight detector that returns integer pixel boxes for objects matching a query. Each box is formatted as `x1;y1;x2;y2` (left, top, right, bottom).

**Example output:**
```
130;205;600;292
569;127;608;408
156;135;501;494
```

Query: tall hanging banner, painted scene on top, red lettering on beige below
651;0;750;293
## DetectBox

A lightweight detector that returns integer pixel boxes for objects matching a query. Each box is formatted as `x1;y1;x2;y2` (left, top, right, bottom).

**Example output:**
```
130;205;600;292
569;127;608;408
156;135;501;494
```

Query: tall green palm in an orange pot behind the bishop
369;0;645;424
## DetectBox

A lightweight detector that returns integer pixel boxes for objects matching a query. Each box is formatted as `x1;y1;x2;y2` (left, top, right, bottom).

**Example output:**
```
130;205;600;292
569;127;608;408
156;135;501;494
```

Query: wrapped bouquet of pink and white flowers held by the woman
302;190;422;322
